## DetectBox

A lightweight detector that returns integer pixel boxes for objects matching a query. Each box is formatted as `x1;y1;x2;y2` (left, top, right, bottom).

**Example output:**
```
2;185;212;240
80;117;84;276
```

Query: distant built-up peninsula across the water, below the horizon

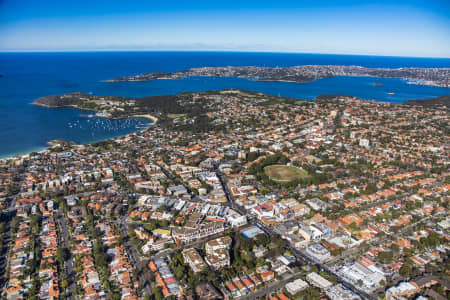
106;65;450;88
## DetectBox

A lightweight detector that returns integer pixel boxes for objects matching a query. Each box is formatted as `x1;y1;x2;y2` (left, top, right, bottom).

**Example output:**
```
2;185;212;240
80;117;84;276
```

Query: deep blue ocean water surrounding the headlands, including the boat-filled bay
0;52;450;157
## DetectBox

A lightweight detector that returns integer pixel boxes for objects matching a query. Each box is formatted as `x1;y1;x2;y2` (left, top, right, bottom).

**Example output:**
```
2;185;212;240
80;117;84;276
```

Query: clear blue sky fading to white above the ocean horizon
0;0;450;57
